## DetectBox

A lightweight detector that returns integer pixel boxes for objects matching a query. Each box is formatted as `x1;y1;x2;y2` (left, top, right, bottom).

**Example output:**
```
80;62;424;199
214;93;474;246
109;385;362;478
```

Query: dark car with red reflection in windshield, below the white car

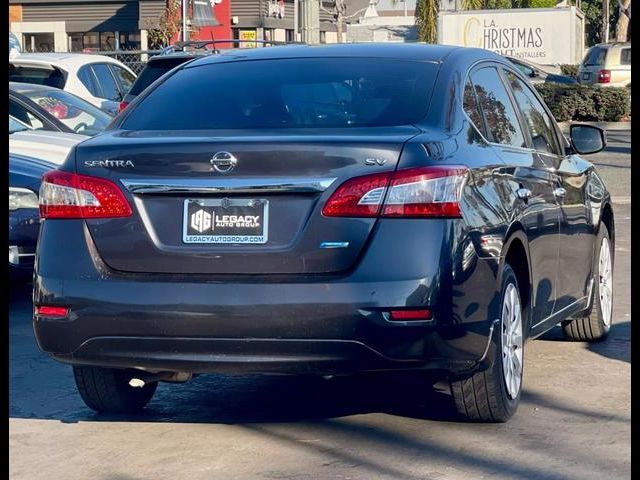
9;82;112;136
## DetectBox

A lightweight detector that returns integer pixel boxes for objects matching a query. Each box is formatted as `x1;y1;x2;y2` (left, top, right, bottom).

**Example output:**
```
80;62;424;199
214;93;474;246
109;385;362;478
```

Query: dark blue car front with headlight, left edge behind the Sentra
9;154;56;280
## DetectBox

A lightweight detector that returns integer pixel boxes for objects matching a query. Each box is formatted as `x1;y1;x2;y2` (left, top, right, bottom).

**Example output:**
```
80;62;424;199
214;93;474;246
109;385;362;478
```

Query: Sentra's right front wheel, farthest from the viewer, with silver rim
562;224;613;342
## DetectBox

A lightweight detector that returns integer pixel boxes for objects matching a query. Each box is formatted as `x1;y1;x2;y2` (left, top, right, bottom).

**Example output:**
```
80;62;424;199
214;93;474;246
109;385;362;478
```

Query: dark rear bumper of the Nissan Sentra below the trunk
34;221;497;374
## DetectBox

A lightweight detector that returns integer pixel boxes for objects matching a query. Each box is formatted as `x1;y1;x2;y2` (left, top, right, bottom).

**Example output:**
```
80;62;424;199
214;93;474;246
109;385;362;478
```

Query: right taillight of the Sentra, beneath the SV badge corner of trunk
322;166;467;218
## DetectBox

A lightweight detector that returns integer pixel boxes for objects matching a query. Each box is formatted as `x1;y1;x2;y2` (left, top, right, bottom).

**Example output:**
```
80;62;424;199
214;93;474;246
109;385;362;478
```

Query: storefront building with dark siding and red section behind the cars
9;0;352;52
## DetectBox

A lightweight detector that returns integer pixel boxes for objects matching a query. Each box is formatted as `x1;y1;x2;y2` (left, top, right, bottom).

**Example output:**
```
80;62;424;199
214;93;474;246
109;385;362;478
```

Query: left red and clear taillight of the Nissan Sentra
39;170;132;218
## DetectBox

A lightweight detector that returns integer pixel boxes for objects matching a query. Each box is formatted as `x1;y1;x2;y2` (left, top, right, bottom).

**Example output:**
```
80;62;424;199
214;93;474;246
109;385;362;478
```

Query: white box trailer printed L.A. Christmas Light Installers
438;7;584;64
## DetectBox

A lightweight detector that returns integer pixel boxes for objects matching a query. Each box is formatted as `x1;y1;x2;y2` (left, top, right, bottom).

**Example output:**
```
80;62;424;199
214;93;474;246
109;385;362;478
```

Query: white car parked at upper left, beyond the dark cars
9;53;136;115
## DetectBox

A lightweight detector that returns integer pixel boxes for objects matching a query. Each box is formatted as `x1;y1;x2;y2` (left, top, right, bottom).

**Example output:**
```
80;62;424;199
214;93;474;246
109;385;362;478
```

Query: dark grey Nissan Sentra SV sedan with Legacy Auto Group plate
34;44;615;421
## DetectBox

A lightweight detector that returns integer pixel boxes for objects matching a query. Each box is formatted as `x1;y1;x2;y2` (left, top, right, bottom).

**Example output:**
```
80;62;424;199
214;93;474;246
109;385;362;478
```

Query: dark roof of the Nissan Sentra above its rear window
188;43;468;68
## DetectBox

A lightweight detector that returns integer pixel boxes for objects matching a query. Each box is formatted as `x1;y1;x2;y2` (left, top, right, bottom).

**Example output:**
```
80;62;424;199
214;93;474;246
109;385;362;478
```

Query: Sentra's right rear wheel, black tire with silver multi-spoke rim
451;264;524;422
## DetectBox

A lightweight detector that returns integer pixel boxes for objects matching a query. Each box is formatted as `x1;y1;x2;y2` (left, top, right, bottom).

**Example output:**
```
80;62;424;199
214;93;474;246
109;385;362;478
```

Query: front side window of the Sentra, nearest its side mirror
507;72;560;155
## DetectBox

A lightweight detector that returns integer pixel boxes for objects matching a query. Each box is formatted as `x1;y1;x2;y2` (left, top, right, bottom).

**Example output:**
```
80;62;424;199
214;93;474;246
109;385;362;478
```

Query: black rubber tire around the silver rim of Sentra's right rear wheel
450;264;528;423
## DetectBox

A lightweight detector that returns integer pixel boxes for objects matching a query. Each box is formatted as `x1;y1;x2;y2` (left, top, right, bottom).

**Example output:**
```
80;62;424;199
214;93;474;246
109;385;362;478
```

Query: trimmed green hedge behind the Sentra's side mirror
535;83;630;122
